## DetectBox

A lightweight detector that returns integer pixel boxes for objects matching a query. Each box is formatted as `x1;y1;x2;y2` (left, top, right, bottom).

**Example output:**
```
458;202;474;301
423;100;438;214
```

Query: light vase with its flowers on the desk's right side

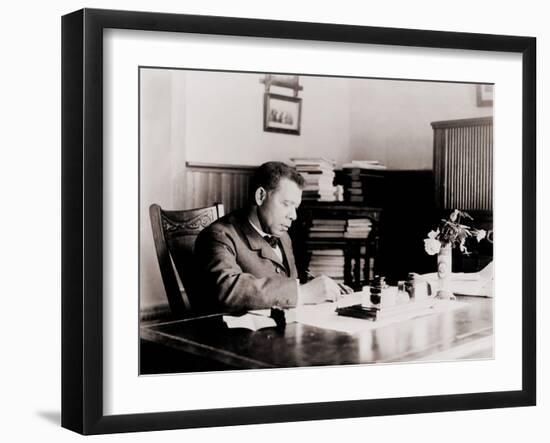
424;209;487;300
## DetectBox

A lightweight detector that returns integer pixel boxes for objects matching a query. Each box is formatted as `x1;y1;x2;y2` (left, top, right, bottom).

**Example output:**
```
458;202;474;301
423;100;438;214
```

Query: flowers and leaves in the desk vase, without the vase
424;209;487;255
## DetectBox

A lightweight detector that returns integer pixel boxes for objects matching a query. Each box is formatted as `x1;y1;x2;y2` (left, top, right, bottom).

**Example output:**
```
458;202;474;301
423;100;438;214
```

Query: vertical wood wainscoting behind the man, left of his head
183;162;257;213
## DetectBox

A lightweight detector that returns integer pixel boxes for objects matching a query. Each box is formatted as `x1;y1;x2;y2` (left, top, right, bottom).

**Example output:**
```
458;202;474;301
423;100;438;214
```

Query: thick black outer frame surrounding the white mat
62;9;536;434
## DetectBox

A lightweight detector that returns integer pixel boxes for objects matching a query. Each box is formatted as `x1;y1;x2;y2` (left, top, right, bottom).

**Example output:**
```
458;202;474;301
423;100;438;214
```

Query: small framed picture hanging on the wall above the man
264;92;302;135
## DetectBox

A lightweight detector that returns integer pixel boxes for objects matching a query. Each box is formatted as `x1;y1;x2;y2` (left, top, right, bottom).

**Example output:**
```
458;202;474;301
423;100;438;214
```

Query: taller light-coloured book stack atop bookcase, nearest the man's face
291;157;336;202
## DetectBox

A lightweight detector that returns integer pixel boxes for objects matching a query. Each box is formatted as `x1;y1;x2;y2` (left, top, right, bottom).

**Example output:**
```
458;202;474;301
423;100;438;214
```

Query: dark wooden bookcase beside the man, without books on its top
291;201;382;290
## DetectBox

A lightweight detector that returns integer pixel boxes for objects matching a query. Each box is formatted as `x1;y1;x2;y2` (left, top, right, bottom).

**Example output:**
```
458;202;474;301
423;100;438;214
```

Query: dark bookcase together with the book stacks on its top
291;157;386;289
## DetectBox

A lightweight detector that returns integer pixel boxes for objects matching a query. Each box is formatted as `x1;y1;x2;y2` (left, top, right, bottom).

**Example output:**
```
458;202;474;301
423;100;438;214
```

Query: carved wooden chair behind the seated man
149;203;224;317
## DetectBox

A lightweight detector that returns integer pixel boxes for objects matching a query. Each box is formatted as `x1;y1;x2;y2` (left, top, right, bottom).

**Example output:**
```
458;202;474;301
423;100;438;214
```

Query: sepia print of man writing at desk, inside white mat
139;67;495;375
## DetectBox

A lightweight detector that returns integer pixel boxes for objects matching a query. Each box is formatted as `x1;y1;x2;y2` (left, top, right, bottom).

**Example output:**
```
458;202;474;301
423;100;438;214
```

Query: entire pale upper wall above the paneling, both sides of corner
174;71;492;169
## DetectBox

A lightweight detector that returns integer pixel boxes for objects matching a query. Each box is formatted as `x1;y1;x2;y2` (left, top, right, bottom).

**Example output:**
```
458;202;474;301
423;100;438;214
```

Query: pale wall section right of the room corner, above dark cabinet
350;80;493;169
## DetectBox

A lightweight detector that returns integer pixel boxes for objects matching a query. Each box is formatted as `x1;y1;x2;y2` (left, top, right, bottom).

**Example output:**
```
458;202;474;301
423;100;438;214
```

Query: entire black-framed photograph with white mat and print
62;9;536;434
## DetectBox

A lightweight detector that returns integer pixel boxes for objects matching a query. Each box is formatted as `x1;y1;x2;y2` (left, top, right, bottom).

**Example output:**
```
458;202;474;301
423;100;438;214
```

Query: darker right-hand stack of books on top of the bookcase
342;160;386;203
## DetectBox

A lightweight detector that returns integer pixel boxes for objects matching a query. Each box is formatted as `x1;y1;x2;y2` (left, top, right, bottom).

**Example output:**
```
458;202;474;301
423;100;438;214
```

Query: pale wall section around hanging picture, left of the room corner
185;71;356;165
